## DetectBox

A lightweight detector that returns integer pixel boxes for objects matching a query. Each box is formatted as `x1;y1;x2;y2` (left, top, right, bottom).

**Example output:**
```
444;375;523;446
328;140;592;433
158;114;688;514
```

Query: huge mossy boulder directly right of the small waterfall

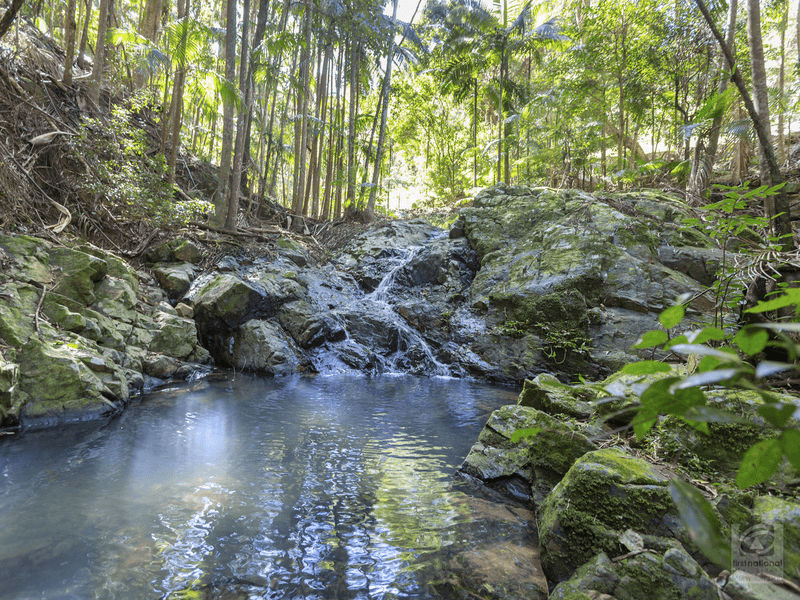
462;185;712;378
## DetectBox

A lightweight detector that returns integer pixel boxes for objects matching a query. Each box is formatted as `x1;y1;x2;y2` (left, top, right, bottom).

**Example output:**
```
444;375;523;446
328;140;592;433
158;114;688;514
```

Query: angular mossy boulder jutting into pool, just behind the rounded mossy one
459;406;596;505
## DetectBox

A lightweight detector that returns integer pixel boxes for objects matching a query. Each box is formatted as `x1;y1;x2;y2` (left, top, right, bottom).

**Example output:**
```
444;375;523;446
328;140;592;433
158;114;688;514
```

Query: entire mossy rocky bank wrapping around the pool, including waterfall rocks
0;185;800;600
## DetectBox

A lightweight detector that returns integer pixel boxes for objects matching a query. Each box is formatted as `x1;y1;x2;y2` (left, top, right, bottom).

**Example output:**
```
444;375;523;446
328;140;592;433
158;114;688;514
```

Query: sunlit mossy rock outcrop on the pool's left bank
0;236;210;426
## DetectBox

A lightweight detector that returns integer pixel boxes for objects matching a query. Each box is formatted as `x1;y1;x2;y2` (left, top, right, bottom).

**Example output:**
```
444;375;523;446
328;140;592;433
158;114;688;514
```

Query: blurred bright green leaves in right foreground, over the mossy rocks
622;298;800;567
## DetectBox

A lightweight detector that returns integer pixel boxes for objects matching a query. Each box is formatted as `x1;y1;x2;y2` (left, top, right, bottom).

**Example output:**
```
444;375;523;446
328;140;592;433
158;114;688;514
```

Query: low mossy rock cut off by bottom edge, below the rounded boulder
550;547;719;600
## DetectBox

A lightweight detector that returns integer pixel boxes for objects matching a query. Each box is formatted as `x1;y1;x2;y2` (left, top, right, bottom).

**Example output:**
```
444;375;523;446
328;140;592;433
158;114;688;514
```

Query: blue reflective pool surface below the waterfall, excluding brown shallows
0;376;514;598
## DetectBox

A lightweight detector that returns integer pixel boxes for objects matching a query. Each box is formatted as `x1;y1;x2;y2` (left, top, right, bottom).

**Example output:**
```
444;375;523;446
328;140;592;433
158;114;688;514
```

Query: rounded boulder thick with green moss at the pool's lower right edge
539;448;685;581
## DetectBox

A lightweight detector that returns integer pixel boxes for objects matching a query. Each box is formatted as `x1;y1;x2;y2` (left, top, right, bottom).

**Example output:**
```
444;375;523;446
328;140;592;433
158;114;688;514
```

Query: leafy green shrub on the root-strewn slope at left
70;96;213;226
